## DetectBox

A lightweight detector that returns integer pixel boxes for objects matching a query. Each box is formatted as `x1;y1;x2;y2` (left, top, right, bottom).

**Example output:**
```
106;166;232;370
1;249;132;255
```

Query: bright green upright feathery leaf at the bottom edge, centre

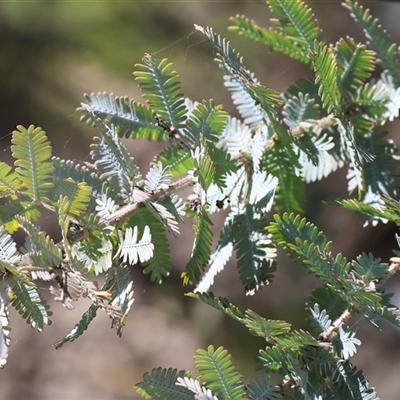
194;346;245;400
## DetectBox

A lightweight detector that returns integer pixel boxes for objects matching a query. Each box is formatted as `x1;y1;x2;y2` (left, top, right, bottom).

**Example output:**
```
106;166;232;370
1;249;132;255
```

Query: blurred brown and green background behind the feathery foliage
0;0;400;400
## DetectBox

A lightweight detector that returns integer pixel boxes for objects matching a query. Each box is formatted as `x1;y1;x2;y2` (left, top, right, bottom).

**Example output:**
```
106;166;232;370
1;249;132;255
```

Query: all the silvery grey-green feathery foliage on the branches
0;0;400;399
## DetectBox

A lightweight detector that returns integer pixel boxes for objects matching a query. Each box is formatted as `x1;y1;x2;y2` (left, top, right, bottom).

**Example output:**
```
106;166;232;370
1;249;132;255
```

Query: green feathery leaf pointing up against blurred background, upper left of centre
133;54;187;130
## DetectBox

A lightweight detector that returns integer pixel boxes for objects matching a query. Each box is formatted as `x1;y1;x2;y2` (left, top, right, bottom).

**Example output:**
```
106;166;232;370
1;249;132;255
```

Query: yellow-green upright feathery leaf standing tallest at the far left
11;125;54;201
